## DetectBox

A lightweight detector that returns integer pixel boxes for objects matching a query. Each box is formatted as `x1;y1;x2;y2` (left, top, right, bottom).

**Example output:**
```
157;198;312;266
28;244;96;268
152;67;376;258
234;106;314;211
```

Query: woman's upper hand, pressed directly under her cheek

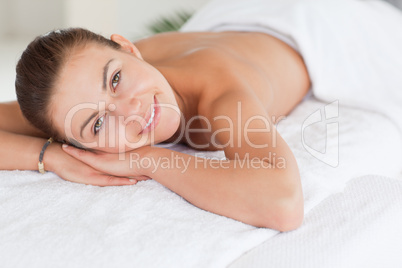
63;144;150;181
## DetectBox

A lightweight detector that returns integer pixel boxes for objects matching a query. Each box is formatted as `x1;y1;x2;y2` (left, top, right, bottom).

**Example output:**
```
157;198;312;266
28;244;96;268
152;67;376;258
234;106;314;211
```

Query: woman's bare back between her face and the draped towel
135;32;310;150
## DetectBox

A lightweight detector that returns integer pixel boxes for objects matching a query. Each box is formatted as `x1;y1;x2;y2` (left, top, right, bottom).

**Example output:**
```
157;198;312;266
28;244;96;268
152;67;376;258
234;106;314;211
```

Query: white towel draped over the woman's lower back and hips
181;0;402;131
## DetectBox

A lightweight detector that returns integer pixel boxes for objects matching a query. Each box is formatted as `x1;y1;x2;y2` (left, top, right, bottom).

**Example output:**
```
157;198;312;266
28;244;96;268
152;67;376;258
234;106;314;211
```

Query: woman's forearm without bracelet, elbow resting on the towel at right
143;148;303;231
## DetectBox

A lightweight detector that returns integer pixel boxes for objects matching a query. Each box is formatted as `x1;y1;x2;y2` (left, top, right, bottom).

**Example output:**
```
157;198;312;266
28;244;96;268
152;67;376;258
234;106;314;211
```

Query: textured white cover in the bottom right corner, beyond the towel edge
229;175;402;268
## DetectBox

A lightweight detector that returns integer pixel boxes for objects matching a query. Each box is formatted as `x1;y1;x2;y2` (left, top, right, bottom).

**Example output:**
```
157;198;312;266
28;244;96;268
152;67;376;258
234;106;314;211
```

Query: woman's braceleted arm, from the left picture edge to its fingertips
0;101;144;186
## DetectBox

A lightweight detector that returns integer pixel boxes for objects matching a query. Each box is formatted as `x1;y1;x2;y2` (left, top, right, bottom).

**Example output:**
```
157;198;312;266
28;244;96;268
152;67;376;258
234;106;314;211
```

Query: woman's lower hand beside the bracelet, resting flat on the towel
44;142;144;186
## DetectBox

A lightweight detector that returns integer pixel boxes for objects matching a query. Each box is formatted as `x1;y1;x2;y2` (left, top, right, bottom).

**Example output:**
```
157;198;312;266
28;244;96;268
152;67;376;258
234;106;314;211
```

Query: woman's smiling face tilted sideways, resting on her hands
50;37;180;153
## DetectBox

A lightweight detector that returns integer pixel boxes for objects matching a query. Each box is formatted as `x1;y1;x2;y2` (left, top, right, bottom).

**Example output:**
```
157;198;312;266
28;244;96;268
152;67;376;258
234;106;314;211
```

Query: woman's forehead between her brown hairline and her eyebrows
50;44;118;140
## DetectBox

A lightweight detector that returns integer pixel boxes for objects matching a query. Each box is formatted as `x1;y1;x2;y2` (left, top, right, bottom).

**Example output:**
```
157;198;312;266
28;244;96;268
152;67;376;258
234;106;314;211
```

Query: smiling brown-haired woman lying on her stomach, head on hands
0;26;310;231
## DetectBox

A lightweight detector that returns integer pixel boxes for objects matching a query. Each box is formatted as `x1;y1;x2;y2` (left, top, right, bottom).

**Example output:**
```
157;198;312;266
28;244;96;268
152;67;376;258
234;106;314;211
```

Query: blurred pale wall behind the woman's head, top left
0;0;208;102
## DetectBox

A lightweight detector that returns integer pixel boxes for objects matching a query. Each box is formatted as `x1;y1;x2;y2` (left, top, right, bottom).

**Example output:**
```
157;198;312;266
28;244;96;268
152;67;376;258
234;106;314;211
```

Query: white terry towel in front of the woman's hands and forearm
0;171;277;268
